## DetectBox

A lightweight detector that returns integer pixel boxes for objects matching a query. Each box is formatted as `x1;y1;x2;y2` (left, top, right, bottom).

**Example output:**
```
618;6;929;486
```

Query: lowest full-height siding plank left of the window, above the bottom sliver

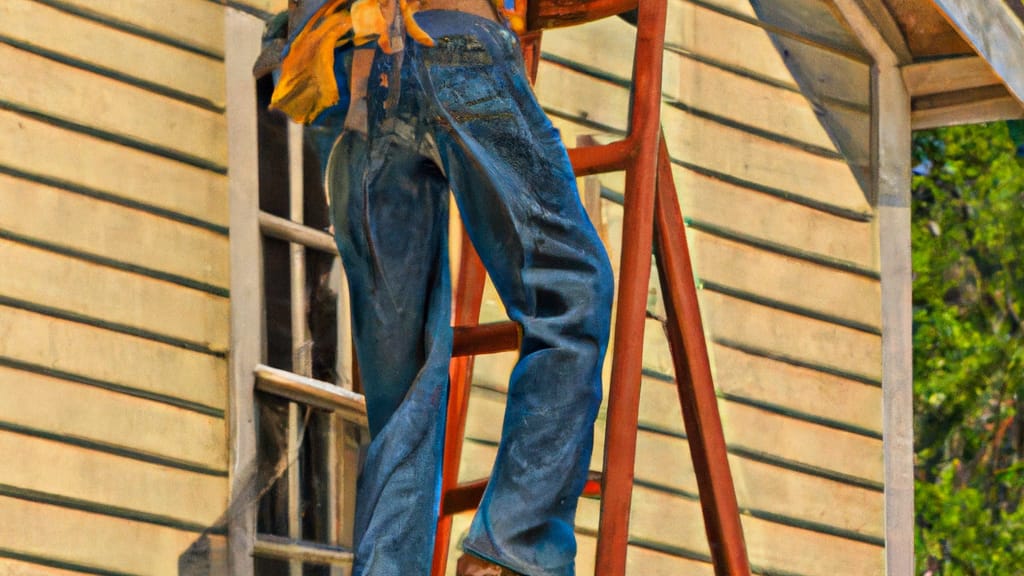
0;496;209;576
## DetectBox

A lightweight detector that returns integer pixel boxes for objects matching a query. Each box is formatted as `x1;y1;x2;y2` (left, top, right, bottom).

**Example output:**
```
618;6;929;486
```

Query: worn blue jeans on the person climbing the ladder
326;10;612;576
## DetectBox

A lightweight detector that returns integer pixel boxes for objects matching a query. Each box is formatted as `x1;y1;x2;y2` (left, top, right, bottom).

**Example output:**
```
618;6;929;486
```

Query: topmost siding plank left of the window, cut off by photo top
44;0;224;54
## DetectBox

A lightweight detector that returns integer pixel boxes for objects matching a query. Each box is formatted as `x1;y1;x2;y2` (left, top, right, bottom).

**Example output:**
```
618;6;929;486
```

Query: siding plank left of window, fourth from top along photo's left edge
0;170;229;289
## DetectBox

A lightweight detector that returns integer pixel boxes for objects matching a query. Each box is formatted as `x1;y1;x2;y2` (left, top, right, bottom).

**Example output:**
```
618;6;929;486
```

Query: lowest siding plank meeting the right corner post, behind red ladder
577;487;885;576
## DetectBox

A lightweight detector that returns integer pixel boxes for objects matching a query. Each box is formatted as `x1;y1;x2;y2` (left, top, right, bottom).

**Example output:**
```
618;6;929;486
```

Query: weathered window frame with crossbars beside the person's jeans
224;6;367;576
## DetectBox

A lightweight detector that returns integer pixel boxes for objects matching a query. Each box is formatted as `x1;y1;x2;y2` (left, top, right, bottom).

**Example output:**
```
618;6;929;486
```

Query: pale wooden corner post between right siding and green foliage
835;0;914;576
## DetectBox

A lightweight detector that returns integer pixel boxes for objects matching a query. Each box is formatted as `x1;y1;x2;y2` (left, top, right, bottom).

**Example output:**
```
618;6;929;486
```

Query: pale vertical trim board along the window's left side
224;8;264;574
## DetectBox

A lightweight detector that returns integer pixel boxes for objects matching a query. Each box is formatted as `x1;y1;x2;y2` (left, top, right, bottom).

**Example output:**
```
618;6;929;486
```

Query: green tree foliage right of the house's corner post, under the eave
911;123;1024;576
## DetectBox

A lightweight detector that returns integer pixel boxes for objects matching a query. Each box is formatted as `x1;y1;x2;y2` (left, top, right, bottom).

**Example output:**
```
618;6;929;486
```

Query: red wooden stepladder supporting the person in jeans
433;0;750;576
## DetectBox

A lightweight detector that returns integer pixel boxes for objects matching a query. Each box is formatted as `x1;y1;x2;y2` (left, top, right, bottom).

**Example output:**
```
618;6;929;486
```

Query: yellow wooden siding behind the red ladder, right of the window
454;0;885;576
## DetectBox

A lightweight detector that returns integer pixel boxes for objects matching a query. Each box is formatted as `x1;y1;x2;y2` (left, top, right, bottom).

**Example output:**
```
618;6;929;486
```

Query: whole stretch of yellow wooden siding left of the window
0;0;229;575
